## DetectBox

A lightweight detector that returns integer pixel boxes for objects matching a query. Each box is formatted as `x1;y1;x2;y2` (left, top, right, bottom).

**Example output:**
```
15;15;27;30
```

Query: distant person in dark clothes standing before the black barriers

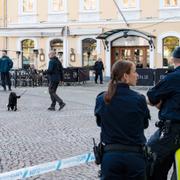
94;58;104;84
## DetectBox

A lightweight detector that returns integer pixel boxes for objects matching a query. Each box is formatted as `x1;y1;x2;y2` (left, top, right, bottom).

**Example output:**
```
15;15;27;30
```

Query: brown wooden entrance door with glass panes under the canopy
111;46;149;68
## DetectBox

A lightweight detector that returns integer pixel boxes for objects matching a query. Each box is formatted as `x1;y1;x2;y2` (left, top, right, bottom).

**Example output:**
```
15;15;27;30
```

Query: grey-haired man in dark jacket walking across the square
47;51;66;111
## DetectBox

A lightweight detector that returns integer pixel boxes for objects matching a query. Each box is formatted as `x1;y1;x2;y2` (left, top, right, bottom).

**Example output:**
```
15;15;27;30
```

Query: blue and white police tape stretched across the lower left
0;153;95;180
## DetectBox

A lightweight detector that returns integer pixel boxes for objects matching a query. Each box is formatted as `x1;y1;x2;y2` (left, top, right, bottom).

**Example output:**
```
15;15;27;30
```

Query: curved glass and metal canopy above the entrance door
96;29;155;49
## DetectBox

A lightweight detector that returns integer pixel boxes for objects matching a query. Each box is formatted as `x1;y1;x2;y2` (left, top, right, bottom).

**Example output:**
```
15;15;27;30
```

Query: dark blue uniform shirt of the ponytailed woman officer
95;84;150;145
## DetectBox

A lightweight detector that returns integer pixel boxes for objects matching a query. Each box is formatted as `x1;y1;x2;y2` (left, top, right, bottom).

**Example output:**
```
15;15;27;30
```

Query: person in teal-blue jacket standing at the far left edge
0;50;13;91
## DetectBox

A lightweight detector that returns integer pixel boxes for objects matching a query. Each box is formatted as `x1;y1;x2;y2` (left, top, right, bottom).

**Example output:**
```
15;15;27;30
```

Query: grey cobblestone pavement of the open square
0;82;172;180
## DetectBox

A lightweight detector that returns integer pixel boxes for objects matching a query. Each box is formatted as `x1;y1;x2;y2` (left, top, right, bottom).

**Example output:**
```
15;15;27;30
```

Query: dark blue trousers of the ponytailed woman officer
101;152;146;180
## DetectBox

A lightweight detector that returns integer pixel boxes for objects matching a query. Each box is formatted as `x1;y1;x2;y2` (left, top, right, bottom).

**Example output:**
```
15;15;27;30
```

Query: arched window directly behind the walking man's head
50;39;63;62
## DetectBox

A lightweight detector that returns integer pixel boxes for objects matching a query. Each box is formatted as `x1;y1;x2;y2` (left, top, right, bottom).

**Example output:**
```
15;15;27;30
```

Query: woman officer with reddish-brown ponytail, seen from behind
95;61;150;180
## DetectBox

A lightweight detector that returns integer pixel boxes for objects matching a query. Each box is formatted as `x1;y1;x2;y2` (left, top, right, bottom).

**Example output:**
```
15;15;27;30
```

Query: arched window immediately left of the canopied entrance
82;38;97;66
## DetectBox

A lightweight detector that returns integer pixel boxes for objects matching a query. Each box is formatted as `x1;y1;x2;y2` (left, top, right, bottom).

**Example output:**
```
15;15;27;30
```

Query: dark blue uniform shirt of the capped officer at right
147;67;180;123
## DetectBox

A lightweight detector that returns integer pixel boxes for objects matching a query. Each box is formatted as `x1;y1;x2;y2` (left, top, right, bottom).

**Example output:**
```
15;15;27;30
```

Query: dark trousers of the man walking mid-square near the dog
49;82;63;107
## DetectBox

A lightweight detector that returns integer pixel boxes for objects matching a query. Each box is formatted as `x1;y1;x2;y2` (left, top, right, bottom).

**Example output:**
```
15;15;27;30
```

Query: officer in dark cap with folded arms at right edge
147;47;180;180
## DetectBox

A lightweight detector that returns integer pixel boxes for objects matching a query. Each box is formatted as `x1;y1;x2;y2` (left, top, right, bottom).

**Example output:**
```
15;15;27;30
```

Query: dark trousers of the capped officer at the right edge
147;125;180;180
